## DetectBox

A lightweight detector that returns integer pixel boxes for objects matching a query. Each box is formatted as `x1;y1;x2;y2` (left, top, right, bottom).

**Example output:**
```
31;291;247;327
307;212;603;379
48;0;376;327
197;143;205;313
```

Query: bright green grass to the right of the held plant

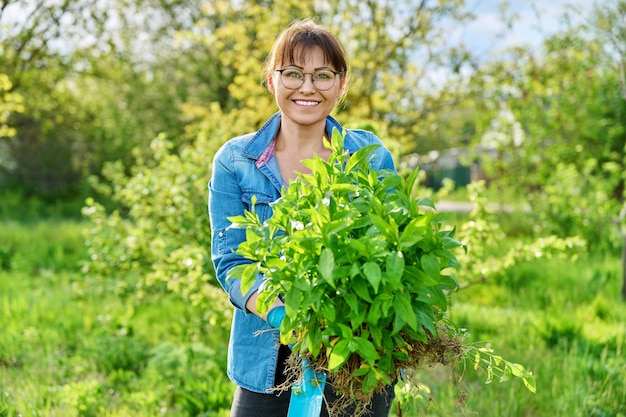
390;255;626;417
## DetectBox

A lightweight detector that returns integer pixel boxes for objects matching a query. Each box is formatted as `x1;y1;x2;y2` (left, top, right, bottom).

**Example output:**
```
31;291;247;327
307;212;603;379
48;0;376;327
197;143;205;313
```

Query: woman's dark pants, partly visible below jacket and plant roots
230;342;394;417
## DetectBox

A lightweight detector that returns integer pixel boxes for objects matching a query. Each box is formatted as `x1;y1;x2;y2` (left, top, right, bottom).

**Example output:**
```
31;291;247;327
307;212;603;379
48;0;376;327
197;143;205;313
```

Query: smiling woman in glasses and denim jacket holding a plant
209;19;395;417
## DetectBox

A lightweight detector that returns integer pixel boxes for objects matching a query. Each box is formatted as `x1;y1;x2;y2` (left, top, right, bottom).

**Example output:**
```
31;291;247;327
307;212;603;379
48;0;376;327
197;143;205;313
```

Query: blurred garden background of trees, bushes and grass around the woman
0;0;626;416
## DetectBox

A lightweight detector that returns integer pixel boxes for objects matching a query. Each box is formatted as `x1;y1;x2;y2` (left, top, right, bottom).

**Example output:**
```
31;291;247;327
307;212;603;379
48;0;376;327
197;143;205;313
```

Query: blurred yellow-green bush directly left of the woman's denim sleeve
82;132;230;323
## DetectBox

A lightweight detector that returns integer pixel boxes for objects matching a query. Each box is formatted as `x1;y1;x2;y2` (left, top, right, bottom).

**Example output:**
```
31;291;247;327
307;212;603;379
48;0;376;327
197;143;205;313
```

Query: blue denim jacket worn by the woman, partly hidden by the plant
209;112;395;393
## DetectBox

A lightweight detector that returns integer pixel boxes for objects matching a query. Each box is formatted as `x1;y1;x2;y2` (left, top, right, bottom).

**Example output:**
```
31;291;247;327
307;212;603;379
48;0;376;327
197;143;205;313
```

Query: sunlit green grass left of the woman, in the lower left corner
0;221;233;417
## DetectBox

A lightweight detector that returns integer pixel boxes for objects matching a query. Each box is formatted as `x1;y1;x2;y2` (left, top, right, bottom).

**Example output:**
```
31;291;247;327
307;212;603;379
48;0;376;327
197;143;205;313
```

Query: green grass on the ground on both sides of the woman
0;221;626;417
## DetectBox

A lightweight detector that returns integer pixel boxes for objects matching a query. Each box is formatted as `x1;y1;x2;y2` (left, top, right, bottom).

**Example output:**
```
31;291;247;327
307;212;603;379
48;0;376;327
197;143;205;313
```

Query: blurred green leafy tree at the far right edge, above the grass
466;1;626;298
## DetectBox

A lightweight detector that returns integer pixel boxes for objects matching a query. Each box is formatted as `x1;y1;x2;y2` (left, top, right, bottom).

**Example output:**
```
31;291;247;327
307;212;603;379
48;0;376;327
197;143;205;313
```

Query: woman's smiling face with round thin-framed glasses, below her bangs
268;46;344;126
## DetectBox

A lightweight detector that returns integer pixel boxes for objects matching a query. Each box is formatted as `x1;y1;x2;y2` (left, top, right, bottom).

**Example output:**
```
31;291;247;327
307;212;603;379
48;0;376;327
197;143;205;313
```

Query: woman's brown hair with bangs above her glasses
265;19;349;88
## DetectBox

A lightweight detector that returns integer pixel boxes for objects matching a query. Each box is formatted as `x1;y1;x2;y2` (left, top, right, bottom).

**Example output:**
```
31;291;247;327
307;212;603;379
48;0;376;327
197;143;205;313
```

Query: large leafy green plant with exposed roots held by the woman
229;130;534;412
